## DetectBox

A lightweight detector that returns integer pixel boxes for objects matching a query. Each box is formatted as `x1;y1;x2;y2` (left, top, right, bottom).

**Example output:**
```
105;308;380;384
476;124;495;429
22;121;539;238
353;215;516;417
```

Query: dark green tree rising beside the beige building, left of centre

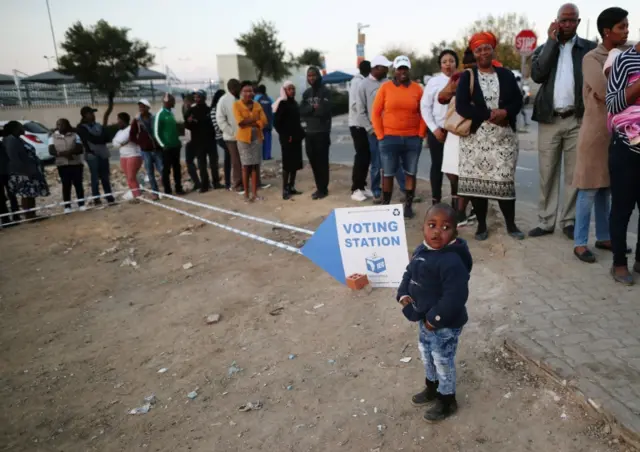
236;20;291;83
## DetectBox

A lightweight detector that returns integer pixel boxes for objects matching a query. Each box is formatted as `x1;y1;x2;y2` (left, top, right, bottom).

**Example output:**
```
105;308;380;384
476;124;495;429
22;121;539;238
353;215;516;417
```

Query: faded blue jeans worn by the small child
418;322;462;395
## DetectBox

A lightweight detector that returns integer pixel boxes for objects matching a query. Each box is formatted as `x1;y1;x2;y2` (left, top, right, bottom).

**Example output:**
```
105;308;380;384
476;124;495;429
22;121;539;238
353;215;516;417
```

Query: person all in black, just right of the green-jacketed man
185;90;223;193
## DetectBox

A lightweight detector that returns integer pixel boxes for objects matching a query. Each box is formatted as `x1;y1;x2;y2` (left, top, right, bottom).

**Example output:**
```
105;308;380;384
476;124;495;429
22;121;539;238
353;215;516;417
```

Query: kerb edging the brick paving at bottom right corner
504;332;640;449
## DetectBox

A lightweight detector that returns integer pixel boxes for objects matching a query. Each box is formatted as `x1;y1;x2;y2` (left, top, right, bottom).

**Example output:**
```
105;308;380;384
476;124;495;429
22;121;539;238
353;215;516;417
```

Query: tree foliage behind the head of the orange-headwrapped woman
463;13;533;69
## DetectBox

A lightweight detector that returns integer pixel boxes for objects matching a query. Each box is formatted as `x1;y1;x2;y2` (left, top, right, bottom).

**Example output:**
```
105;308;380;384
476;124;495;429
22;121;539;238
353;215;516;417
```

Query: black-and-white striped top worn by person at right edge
606;46;640;153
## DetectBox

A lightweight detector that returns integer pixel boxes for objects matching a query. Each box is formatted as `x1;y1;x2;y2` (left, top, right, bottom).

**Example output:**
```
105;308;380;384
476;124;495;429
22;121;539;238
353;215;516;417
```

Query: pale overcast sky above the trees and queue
0;0;640;81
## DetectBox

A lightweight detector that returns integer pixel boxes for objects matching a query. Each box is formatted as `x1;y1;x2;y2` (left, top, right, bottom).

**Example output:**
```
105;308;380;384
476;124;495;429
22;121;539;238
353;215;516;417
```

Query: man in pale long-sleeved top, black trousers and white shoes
349;60;373;201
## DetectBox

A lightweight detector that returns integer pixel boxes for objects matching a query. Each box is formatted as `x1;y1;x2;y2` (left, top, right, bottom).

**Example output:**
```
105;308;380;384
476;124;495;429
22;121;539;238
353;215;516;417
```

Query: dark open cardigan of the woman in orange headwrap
456;67;522;133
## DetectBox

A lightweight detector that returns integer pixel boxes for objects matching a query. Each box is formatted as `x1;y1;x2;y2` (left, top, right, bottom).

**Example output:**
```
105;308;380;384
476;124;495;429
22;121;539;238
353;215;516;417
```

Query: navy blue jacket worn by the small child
397;238;473;328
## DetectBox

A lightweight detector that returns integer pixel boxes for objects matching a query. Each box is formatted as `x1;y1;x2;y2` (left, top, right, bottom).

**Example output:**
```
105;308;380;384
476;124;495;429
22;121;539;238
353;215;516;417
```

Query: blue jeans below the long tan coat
574;188;611;247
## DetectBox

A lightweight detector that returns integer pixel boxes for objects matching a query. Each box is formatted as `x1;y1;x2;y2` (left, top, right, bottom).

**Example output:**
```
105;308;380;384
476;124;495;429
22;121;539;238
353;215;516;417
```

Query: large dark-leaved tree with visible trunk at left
58;20;153;122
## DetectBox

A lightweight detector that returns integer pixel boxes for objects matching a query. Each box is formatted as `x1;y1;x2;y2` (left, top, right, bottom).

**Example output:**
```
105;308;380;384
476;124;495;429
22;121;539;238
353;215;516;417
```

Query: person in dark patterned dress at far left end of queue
3;121;49;219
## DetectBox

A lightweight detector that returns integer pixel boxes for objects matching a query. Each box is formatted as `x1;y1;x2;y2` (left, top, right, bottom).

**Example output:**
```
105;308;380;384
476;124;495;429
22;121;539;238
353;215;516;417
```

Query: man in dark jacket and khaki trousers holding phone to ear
529;3;596;240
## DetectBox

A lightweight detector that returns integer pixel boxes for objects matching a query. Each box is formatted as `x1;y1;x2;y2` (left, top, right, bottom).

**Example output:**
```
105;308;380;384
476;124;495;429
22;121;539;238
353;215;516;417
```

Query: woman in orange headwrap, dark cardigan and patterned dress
456;32;524;240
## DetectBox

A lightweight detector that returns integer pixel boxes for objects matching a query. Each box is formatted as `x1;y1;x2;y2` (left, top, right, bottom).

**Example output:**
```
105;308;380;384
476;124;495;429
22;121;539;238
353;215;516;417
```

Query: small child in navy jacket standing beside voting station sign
397;204;473;422
